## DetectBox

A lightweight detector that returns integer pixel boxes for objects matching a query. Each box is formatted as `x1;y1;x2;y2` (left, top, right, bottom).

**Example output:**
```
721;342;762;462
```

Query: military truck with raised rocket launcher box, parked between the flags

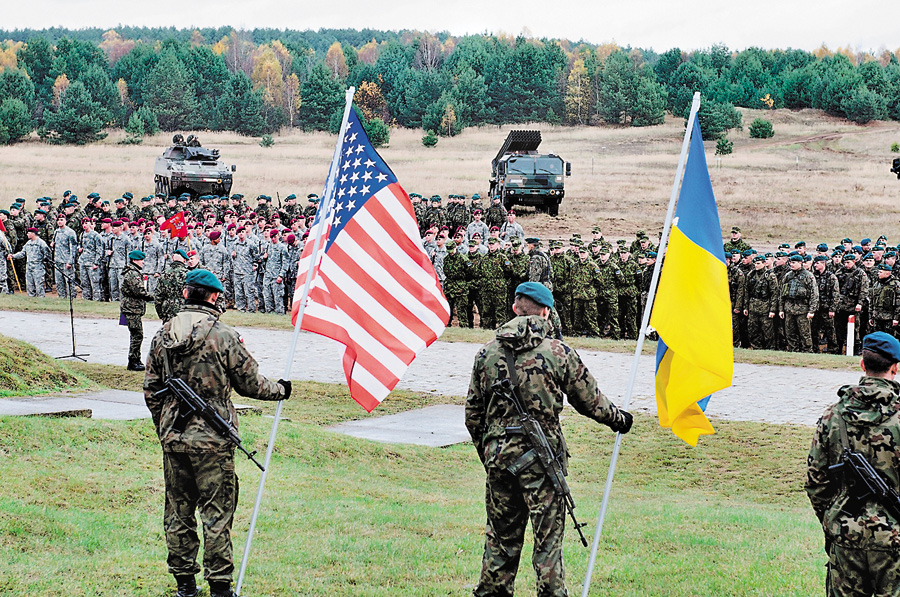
490;131;572;216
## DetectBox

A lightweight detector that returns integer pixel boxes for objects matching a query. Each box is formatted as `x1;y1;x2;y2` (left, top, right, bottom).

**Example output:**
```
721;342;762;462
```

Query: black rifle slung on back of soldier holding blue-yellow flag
491;378;588;547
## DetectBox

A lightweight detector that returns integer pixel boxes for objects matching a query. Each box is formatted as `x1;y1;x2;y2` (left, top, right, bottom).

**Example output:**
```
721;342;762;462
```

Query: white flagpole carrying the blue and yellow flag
581;91;700;597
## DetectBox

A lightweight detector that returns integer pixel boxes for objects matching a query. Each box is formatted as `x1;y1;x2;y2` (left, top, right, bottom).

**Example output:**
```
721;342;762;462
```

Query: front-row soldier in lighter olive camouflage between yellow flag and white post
778;255;819;352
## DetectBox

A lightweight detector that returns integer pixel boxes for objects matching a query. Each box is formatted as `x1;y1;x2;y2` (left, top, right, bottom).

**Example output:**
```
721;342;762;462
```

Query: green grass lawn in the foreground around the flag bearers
0;364;824;596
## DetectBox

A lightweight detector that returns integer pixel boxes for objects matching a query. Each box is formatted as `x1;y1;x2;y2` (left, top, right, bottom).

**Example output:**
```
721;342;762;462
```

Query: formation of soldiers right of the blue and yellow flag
724;227;900;354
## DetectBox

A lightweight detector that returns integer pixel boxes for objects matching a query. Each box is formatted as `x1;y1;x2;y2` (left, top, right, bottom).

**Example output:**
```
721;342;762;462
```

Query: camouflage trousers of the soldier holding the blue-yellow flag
473;465;567;597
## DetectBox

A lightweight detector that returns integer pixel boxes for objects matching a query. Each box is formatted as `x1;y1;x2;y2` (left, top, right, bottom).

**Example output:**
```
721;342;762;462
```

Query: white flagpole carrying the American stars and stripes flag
235;87;356;595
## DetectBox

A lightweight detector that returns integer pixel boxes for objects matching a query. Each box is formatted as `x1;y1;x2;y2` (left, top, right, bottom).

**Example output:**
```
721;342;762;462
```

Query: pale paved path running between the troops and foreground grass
0;311;859;425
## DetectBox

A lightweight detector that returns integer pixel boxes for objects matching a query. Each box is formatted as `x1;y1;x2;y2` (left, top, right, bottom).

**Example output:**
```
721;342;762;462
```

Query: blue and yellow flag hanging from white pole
650;116;734;446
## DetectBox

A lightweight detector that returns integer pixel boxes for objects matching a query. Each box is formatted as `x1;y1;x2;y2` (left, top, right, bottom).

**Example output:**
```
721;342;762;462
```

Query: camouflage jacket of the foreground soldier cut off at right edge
806;377;900;550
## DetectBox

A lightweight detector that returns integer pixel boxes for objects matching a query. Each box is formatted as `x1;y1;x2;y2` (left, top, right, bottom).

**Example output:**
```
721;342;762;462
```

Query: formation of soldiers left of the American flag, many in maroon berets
0;191;319;318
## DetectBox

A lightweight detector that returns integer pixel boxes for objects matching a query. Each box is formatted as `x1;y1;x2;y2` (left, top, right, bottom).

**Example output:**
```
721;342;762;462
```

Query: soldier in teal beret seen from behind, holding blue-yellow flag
466;282;632;596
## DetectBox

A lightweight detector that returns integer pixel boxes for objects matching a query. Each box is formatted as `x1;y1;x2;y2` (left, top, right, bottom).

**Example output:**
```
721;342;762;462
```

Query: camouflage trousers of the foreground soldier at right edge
825;544;900;597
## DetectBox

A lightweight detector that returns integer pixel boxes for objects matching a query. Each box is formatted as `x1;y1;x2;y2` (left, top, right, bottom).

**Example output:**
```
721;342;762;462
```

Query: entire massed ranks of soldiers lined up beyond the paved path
7;191;900;353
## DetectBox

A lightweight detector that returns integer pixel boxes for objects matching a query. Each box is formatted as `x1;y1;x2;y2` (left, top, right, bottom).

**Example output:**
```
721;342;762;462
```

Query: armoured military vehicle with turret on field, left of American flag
153;135;237;197
